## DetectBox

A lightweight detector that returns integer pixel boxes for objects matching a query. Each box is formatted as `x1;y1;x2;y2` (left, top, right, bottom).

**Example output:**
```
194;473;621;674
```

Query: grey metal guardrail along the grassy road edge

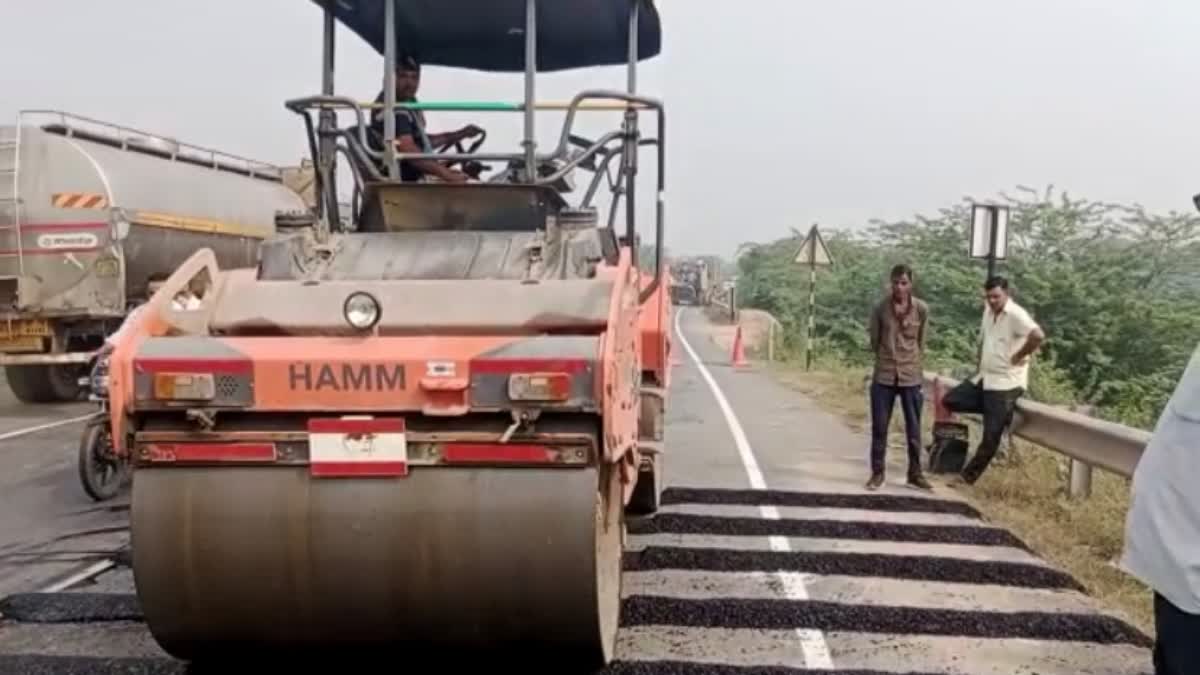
925;372;1151;485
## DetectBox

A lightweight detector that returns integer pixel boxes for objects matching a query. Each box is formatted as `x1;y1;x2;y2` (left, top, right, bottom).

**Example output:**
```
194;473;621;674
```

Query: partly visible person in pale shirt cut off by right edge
1121;346;1200;675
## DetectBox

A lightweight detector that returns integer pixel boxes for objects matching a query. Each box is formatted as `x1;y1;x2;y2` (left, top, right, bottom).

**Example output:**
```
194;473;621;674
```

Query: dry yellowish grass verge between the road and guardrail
773;364;1154;635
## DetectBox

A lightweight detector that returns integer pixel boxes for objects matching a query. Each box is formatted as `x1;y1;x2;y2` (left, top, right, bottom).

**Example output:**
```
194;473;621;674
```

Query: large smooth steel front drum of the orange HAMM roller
131;467;624;668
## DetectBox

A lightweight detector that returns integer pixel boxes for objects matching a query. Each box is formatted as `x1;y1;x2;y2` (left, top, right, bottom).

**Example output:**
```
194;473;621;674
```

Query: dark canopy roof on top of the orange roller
312;0;662;72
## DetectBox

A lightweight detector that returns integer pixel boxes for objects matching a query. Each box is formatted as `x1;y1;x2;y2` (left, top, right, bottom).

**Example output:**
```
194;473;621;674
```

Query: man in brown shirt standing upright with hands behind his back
866;264;930;490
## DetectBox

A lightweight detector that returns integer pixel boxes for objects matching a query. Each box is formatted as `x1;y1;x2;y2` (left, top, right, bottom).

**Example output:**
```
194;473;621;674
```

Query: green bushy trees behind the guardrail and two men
737;187;1200;429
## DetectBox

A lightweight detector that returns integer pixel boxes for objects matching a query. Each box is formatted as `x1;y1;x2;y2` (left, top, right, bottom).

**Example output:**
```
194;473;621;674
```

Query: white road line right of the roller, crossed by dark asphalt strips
674;311;833;670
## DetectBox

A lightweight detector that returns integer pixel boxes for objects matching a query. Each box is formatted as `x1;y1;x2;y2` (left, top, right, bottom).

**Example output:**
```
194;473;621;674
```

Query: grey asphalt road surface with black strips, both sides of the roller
0;311;1152;675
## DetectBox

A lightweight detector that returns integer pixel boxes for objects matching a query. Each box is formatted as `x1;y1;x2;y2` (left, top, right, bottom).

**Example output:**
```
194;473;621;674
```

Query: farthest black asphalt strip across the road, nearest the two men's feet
661;488;983;520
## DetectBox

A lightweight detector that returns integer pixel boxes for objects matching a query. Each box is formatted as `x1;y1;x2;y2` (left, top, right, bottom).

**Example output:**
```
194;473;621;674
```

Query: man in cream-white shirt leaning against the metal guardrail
943;276;1045;484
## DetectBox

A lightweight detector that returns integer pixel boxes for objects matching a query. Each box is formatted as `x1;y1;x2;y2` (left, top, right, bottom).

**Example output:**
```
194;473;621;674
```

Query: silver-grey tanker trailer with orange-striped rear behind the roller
0;110;311;402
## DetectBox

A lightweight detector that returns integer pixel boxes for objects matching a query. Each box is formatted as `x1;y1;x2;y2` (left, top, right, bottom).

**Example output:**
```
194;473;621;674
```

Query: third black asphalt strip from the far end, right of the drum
624;546;1085;592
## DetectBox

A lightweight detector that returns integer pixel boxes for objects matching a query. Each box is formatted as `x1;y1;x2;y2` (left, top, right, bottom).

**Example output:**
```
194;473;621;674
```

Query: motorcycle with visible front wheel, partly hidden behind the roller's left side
79;354;132;502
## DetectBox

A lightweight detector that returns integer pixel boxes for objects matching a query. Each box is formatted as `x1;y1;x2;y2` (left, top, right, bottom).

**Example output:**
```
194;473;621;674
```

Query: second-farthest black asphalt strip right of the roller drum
629;513;1030;551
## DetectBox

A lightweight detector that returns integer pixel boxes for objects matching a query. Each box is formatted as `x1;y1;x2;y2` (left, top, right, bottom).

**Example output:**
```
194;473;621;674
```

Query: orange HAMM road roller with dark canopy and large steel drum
109;0;670;673
